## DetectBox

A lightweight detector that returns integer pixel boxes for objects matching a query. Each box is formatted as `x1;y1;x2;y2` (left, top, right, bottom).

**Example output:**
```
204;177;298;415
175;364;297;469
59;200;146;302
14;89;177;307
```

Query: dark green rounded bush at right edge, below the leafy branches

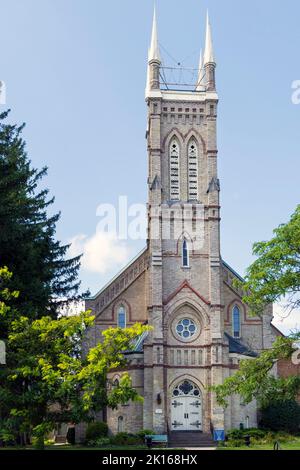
261;400;300;434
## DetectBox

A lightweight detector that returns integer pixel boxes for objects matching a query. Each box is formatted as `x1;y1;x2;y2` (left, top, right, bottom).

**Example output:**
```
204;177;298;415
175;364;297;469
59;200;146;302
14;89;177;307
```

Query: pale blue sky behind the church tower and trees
0;0;300;332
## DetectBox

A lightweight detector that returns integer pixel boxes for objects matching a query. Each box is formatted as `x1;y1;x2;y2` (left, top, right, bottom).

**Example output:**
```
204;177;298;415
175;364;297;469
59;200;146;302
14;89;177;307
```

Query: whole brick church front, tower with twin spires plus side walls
79;11;276;434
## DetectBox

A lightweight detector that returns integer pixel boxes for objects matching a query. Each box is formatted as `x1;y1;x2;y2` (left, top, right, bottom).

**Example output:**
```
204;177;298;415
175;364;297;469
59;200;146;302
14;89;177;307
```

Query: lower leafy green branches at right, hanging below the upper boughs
212;334;300;407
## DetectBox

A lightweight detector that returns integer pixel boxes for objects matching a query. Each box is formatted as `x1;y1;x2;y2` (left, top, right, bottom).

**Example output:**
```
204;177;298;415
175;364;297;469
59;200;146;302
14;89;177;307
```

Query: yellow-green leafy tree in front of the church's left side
0;270;148;448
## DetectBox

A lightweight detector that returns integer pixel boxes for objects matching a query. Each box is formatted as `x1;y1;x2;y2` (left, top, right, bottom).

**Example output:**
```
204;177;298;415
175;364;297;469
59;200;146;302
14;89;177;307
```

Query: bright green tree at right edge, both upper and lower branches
214;206;300;407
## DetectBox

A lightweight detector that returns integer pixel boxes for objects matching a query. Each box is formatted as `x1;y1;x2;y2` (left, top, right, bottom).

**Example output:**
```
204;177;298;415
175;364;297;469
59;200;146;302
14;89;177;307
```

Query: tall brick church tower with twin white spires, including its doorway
146;6;223;432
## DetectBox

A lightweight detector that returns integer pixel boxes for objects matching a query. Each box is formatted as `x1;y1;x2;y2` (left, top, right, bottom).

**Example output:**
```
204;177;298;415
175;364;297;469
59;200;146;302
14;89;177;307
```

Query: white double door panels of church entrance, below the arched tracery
171;396;202;431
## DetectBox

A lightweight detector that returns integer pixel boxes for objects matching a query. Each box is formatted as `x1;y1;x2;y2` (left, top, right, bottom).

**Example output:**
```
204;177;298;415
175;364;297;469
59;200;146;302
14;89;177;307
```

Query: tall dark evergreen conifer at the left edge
0;112;80;318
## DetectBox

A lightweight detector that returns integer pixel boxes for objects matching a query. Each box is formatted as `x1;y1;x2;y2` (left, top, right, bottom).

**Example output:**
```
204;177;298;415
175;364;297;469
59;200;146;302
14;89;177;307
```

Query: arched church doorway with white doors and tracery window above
171;380;202;431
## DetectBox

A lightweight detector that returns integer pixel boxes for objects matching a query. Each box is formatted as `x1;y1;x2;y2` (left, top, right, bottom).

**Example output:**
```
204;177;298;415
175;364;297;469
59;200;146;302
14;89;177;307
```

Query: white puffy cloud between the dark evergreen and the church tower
69;232;130;274
